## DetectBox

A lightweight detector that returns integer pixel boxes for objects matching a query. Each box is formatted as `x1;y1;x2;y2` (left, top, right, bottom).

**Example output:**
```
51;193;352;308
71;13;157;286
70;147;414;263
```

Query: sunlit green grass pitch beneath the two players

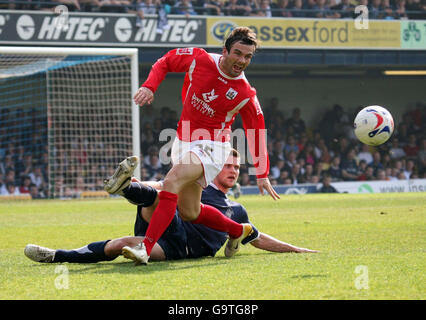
0;193;426;300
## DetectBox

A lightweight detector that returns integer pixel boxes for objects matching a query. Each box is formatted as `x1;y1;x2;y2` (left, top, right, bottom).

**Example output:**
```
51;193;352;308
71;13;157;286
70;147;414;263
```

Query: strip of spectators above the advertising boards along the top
0;0;426;19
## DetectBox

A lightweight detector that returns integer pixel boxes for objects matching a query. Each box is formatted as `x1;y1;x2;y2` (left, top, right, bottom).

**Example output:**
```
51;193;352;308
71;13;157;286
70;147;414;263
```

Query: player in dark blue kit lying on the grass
24;150;317;264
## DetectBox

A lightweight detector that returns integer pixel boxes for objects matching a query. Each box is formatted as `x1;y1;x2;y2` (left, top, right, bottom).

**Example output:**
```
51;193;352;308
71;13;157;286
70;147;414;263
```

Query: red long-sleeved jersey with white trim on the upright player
142;48;269;178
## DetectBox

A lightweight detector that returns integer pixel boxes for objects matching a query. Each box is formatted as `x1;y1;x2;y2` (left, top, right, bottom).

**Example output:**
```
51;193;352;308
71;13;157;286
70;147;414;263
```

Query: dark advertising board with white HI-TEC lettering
0;11;203;44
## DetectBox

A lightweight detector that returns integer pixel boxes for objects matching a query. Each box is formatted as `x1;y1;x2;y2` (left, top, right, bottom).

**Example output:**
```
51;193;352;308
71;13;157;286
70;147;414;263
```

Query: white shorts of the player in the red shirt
171;137;232;188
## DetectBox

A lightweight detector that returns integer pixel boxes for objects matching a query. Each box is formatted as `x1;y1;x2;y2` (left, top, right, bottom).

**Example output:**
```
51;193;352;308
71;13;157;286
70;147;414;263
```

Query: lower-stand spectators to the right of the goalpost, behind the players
135;98;426;192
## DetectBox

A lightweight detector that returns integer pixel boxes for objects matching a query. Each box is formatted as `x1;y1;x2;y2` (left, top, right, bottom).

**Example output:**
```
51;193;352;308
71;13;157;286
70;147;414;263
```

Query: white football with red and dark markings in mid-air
354;106;394;146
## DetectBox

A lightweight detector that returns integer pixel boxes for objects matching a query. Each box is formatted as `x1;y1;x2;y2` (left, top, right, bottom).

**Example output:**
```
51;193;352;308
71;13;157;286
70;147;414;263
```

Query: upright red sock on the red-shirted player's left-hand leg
143;191;178;256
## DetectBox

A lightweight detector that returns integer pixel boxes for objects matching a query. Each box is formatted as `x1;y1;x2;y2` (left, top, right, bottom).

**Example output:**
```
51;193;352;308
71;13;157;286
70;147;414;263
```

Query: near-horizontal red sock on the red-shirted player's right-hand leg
192;204;243;238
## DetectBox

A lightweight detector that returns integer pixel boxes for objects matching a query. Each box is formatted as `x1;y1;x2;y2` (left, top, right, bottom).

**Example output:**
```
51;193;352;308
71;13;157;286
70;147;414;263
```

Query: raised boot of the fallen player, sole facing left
104;156;139;195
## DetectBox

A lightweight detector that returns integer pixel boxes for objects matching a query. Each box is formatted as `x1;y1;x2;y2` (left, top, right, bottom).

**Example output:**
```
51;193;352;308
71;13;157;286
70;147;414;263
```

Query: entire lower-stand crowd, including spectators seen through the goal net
0;98;426;198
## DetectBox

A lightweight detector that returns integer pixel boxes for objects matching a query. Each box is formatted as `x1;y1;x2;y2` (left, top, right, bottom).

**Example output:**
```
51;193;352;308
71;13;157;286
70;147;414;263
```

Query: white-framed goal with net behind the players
0;47;140;198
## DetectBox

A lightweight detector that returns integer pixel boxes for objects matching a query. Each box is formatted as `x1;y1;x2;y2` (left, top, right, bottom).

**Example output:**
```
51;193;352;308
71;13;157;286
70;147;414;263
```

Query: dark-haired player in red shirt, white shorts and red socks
105;27;280;262
